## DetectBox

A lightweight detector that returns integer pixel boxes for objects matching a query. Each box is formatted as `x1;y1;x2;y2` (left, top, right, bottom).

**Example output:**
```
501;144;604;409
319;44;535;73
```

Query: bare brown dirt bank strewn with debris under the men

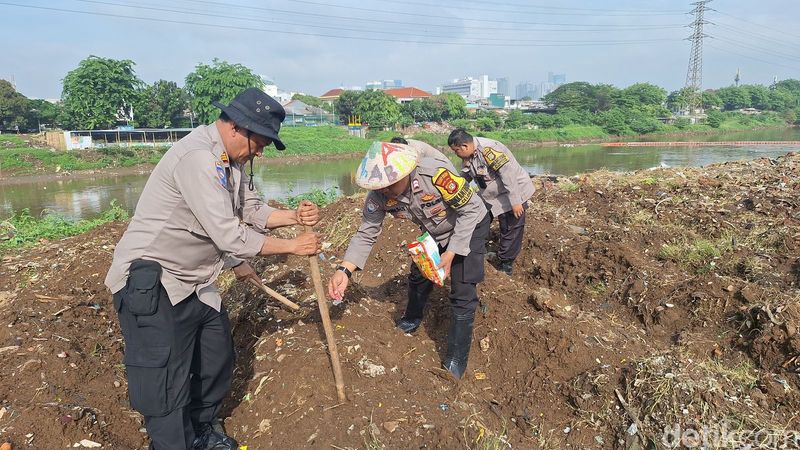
0;154;800;450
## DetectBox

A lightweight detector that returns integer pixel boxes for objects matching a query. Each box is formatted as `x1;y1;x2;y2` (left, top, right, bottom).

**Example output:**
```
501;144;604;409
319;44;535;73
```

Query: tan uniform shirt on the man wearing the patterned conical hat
344;158;487;269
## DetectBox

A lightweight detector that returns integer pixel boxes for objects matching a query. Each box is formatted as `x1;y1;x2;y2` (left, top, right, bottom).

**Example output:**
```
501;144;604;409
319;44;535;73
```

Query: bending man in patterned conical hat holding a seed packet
328;142;491;379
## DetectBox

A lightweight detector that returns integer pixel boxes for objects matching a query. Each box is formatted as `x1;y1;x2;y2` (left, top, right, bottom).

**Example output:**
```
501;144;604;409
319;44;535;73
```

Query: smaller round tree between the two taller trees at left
134;80;189;128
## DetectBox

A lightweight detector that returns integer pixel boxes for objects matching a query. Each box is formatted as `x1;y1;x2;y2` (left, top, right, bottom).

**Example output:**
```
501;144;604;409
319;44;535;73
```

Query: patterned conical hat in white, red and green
356;142;417;191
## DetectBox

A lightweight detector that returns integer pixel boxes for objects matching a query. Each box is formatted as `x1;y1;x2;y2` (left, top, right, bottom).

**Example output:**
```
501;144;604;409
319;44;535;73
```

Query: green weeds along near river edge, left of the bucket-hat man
0;201;128;251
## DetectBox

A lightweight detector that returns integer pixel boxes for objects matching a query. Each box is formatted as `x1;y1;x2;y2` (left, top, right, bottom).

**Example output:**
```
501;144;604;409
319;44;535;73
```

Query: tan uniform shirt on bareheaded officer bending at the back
461;137;536;217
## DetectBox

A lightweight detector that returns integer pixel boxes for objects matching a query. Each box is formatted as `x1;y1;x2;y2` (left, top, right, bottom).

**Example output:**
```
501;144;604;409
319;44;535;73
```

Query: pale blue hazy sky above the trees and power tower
0;0;800;98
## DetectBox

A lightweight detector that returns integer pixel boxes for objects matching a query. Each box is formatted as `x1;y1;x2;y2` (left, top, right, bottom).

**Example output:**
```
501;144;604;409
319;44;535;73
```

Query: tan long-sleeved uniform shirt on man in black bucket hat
105;124;274;310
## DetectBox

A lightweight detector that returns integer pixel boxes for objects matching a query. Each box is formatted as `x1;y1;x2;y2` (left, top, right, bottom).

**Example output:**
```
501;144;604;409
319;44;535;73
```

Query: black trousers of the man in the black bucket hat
114;272;234;450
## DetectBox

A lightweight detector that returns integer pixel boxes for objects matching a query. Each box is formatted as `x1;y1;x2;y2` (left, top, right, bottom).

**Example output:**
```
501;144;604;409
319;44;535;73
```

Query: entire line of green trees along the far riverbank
0;56;800;135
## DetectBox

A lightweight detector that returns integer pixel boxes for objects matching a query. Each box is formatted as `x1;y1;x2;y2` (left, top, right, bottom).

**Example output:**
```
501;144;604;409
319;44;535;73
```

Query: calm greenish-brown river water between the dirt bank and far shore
0;129;800;219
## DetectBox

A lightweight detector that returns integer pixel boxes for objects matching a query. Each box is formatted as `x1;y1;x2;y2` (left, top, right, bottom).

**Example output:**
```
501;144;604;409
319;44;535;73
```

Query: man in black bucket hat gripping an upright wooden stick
105;88;320;450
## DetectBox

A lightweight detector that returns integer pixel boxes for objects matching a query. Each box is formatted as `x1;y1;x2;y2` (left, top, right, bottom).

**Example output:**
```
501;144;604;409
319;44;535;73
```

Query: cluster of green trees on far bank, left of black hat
0;56;263;131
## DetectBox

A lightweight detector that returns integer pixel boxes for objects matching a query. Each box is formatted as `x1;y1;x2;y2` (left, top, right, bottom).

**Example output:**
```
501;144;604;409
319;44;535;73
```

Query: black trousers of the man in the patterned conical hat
408;213;492;316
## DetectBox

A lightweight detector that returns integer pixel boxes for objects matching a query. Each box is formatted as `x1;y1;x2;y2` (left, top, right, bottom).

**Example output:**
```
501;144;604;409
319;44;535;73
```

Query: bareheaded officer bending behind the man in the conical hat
447;128;535;275
